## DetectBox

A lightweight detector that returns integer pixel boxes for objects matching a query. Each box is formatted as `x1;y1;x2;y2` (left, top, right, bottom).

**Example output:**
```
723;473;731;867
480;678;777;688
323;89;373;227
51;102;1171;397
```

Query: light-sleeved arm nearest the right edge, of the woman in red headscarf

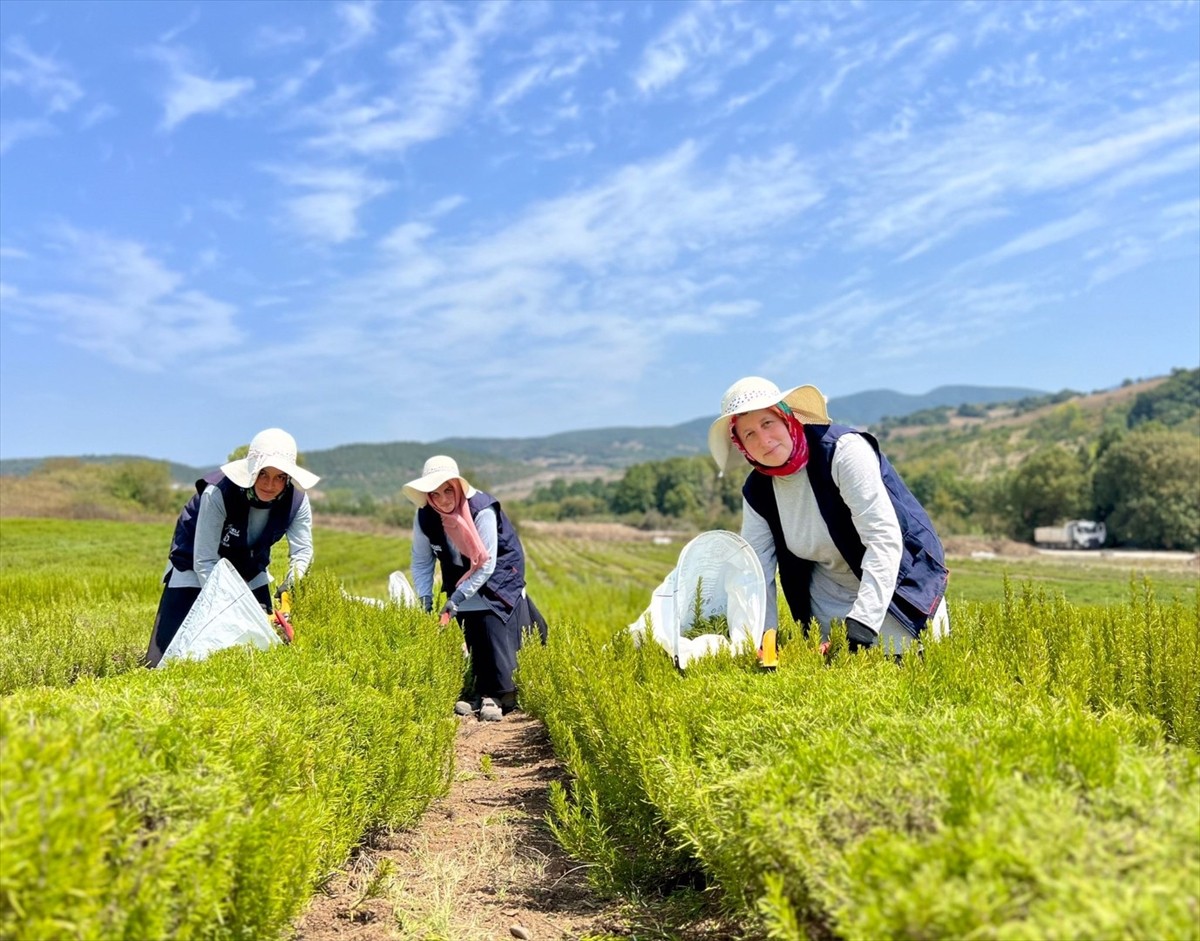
832;434;904;630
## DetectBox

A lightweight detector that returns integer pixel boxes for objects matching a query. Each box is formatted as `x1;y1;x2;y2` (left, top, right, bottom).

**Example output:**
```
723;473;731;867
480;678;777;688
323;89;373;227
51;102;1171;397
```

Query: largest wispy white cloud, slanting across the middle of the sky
204;143;821;416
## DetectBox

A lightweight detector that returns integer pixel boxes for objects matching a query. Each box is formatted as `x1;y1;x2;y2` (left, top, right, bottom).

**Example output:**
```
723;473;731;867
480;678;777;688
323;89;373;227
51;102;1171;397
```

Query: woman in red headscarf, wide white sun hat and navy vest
708;376;949;652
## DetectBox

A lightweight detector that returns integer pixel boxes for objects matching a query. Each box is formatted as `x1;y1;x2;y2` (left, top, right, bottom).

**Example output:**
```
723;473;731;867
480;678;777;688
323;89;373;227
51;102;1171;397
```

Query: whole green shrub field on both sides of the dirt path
0;517;1200;939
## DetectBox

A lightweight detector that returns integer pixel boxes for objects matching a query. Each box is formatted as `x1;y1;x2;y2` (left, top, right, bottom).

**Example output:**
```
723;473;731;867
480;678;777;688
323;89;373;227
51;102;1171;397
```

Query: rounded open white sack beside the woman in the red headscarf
629;529;767;667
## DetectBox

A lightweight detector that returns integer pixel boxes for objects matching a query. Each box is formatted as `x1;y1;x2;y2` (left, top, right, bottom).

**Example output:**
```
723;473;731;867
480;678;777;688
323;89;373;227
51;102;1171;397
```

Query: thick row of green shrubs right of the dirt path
520;587;1200;939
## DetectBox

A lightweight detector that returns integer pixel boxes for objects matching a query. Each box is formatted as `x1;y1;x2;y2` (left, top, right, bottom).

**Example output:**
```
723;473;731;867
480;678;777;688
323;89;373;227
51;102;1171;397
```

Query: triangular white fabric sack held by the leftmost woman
158;559;283;666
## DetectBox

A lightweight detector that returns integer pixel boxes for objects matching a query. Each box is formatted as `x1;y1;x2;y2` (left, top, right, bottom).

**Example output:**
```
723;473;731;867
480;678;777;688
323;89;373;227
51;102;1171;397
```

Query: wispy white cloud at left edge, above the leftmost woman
5;227;241;372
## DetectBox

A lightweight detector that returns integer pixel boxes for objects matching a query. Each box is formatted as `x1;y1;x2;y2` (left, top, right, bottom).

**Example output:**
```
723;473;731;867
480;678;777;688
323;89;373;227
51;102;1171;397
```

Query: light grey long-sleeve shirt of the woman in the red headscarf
742;434;936;646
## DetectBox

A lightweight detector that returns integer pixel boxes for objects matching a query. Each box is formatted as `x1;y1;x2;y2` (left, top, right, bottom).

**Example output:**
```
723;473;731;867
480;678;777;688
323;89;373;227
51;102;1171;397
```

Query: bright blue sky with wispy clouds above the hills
0;0;1200;464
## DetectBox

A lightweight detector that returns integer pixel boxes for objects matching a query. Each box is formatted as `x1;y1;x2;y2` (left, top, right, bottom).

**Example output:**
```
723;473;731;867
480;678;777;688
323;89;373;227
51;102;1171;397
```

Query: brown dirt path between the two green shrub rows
295;713;630;941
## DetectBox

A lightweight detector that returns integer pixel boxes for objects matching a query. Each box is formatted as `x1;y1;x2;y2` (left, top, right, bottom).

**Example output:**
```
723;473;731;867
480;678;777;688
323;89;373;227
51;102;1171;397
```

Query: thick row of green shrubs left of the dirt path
0;576;462;941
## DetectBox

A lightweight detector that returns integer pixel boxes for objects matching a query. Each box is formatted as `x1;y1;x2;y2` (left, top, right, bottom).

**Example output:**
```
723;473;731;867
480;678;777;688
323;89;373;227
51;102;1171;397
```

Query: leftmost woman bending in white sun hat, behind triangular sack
145;428;320;666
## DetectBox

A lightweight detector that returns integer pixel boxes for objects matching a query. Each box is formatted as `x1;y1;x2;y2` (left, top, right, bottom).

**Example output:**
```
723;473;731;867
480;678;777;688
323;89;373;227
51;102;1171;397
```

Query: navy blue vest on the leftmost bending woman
170;471;304;582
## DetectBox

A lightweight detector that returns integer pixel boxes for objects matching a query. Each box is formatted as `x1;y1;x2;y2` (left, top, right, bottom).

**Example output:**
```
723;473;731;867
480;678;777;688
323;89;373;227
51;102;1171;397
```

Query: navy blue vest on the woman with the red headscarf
742;425;949;637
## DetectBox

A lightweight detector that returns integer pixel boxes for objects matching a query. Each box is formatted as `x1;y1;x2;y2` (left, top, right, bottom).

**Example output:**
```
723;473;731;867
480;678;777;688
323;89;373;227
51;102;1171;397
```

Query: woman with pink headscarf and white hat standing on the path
404;455;546;721
